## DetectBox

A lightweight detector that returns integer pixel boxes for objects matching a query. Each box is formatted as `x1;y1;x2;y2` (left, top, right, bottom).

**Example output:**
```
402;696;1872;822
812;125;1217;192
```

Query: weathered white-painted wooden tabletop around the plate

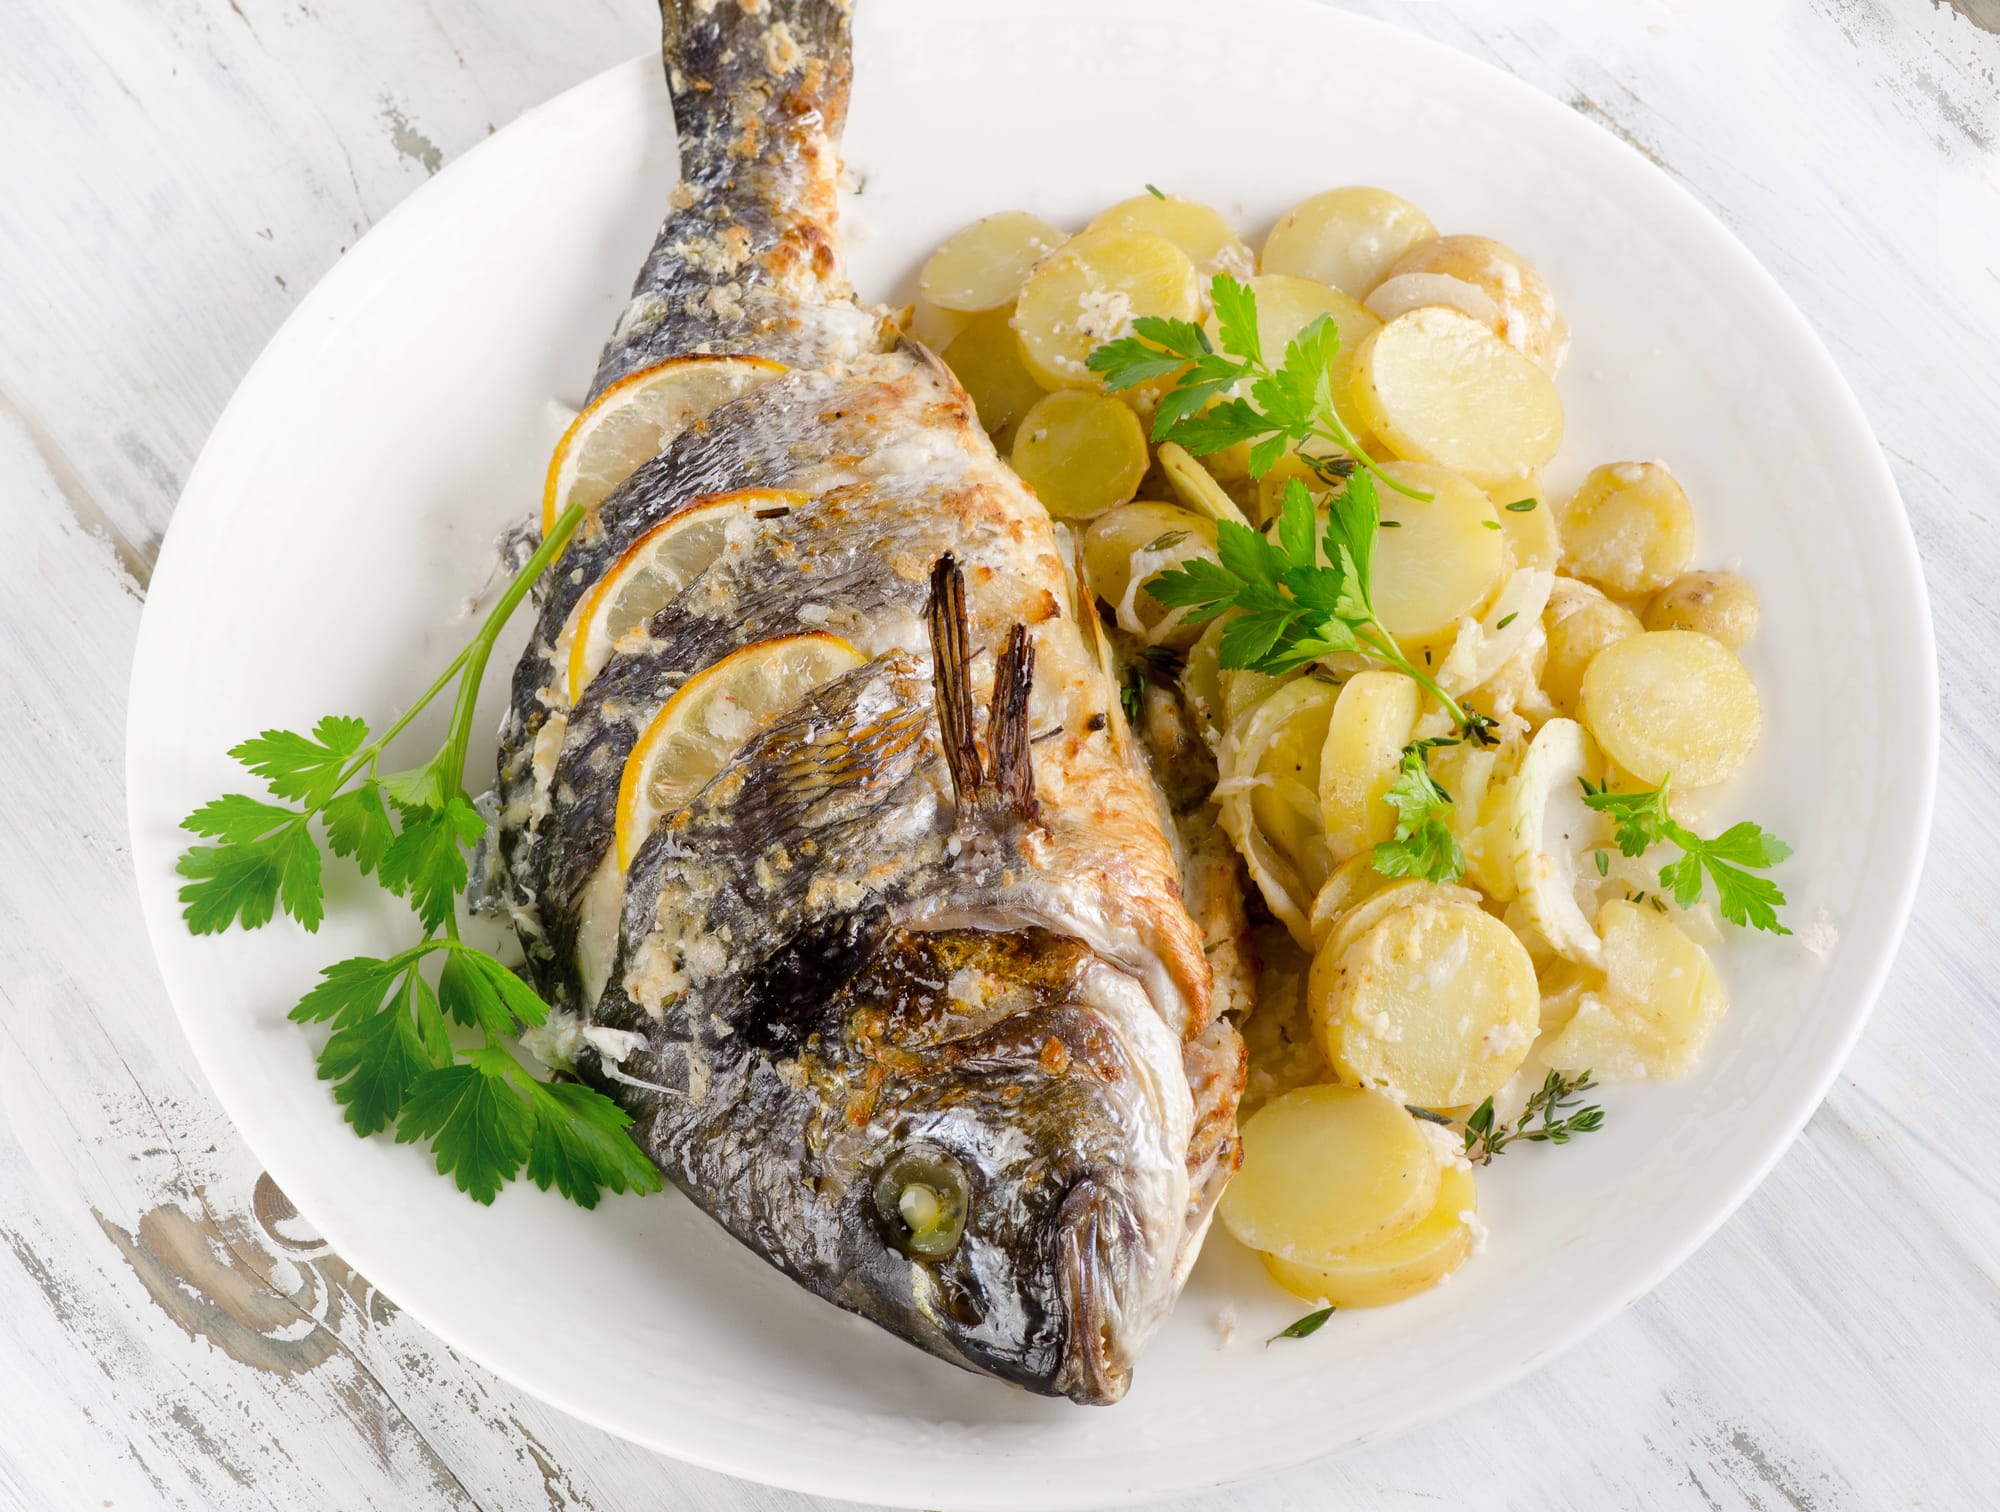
0;0;2000;1512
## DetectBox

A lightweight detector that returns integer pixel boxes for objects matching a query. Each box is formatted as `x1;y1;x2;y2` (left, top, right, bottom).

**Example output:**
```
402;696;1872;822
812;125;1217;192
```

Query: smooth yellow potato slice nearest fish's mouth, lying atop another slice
1220;1086;1440;1264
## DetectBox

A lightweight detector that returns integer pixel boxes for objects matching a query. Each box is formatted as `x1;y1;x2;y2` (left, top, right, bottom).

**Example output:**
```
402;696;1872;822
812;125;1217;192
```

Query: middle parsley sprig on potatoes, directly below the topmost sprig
1146;472;1494;742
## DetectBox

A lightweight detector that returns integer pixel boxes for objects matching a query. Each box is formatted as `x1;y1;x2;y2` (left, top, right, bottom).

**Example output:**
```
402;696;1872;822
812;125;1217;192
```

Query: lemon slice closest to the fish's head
616;634;868;870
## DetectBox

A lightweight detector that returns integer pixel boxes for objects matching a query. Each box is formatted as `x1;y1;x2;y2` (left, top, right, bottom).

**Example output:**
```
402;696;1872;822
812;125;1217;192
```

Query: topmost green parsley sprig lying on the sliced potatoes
1084;274;1430;498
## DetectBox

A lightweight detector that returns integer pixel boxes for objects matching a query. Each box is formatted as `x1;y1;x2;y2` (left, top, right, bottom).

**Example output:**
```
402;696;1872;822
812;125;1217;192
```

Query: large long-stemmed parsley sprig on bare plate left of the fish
178;506;660;1208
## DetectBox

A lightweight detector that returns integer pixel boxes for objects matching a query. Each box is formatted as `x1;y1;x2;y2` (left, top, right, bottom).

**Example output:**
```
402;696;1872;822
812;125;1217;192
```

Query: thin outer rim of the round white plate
124;0;1940;1508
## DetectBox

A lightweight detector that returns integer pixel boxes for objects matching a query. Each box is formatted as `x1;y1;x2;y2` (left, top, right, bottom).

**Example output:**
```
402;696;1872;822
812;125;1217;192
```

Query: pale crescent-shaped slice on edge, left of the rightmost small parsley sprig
1504;720;1610;966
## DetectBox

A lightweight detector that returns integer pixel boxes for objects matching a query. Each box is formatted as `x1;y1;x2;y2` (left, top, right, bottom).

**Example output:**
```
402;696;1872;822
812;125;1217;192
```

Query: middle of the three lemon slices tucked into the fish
556;488;810;704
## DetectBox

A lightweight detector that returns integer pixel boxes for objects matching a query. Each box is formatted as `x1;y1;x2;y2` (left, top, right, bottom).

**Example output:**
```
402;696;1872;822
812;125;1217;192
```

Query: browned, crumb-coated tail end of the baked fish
592;0;852;394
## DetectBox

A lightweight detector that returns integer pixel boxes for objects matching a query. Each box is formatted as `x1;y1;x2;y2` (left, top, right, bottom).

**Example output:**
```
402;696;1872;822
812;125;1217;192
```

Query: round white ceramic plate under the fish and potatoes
128;0;1936;1508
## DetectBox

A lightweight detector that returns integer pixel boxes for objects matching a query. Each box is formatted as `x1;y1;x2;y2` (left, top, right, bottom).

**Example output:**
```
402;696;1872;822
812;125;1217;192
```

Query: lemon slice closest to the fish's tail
542;356;784;534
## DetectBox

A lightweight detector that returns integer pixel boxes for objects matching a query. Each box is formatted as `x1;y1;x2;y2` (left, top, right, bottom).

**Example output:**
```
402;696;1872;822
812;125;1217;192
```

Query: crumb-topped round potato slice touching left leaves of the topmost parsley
1014;230;1202;390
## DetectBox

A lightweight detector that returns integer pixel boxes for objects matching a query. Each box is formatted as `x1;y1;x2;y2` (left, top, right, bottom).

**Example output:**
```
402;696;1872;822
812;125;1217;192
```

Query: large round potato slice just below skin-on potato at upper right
1354;308;1562;488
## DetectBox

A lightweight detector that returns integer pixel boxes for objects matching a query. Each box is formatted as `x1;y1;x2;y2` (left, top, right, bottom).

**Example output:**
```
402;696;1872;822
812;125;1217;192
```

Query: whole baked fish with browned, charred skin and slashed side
500;0;1244;1402
